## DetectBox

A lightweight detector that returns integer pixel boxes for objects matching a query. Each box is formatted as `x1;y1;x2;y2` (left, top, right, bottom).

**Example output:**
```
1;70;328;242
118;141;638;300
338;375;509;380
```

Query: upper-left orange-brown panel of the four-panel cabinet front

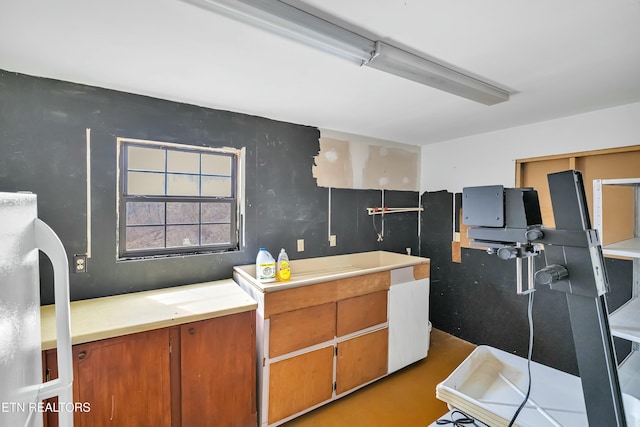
269;303;336;357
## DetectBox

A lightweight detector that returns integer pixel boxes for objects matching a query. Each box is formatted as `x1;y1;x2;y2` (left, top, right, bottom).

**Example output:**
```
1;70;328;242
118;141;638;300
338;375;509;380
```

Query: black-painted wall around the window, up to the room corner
0;70;419;304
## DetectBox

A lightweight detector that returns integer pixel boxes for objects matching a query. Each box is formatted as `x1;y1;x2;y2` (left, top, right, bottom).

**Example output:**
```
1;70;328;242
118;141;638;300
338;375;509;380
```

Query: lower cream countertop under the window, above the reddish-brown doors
40;279;258;350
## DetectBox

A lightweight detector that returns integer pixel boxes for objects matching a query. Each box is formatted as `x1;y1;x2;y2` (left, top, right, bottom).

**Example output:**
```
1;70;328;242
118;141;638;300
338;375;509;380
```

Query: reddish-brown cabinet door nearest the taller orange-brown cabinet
180;311;257;427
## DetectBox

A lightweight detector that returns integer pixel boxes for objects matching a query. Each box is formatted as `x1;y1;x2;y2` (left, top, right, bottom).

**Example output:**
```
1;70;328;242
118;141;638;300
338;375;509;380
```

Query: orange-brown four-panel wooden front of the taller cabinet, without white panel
247;271;390;426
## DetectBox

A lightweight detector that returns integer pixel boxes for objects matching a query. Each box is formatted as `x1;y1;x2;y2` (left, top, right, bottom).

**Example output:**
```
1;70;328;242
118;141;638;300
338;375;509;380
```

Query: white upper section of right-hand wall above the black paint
420;103;640;193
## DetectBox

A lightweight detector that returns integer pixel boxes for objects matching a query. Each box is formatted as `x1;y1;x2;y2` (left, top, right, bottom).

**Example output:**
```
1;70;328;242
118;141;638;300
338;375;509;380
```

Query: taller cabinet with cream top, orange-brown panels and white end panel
234;254;429;427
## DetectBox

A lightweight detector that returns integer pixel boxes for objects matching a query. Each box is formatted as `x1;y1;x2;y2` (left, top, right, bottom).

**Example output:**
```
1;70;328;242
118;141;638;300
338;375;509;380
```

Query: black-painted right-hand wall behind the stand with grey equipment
421;191;633;375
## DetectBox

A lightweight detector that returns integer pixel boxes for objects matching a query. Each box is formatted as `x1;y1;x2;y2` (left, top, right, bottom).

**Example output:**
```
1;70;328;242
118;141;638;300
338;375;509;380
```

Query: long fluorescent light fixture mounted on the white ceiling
182;0;510;105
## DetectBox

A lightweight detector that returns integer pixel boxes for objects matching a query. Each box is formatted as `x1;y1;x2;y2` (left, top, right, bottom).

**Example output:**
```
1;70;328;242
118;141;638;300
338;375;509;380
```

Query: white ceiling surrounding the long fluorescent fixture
0;0;640;145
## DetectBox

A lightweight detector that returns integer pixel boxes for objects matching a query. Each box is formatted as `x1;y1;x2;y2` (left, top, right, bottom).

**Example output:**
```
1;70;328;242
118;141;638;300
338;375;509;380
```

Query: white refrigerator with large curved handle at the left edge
0;192;74;427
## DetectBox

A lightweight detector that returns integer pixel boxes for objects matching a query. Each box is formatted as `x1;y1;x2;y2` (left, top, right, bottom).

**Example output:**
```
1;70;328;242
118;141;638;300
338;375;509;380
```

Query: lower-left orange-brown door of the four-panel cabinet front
268;345;335;424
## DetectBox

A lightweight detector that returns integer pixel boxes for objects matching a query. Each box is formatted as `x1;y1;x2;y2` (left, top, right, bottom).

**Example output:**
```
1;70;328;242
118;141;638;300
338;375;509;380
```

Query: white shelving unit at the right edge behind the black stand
593;178;640;399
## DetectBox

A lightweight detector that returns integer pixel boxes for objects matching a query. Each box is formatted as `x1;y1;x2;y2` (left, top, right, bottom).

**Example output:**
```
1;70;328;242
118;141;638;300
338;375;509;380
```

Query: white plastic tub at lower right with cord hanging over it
436;346;640;427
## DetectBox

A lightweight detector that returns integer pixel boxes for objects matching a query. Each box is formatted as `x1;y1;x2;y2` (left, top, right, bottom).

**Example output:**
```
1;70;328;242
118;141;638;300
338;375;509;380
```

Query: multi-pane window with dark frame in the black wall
118;138;240;258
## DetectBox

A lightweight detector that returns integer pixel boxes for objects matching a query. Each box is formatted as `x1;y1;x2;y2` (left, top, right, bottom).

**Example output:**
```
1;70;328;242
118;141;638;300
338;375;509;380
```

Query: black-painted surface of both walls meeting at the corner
0;70;632;373
